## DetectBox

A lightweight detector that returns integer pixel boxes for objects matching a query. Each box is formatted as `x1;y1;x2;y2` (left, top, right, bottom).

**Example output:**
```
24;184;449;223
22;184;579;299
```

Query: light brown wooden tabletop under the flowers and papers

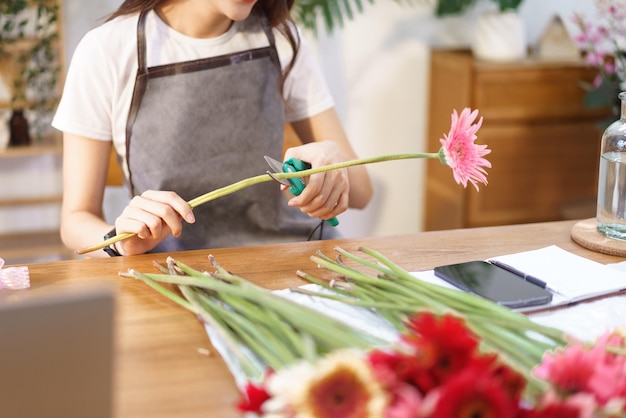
4;221;622;418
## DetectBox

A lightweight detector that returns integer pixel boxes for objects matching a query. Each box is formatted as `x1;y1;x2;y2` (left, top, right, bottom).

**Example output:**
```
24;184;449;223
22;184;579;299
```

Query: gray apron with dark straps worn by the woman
126;12;336;252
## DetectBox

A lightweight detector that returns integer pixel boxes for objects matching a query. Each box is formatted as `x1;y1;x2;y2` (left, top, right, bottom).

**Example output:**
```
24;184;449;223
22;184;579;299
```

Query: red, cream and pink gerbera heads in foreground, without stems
238;313;626;418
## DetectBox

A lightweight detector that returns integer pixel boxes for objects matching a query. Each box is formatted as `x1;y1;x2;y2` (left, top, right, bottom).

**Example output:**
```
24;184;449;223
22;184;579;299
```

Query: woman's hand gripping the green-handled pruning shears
285;141;350;219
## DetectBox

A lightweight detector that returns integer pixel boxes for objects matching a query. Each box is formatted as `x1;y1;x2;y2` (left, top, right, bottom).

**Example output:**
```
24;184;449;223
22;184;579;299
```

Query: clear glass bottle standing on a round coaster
596;92;626;240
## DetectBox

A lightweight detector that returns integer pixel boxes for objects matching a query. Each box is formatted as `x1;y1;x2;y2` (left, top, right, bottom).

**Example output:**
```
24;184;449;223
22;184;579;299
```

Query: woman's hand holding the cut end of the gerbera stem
115;190;195;255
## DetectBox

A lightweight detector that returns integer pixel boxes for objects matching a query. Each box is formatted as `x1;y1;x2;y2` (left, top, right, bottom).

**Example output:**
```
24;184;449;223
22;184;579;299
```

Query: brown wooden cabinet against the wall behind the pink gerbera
424;50;610;230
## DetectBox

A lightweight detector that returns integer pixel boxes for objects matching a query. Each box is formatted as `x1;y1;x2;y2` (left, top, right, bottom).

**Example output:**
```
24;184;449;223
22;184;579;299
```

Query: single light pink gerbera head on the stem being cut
440;108;491;190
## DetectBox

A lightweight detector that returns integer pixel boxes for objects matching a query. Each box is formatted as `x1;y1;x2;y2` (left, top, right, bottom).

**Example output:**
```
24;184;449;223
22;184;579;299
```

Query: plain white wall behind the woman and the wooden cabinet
64;0;594;236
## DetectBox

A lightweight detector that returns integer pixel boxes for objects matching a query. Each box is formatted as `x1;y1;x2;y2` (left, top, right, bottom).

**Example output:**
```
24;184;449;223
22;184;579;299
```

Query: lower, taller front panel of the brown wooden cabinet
466;122;601;226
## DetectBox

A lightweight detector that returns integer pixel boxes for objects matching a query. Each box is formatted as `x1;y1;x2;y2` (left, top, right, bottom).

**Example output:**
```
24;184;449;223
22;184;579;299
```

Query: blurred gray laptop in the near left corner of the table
0;288;114;418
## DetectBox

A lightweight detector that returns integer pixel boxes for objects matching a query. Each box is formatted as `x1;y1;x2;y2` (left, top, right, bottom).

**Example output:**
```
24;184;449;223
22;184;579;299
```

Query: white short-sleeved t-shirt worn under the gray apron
52;11;334;165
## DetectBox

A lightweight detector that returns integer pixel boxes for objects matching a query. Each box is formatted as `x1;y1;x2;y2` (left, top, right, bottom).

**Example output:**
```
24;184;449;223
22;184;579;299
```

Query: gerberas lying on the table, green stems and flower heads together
124;243;626;418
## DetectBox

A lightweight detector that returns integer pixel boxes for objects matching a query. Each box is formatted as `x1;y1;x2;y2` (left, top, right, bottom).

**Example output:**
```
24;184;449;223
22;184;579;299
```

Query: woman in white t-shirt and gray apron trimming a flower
53;0;372;257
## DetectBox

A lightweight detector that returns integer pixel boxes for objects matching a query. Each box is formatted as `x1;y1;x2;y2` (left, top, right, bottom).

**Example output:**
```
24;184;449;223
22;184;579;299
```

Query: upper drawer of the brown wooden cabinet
472;66;606;121
